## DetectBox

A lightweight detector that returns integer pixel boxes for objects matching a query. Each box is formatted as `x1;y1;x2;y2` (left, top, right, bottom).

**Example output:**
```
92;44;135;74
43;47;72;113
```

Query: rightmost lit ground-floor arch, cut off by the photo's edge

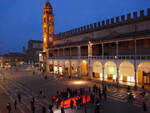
137;62;150;84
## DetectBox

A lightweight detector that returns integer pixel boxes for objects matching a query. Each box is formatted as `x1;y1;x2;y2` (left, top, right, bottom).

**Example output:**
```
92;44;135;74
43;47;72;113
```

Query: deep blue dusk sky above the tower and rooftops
0;0;150;53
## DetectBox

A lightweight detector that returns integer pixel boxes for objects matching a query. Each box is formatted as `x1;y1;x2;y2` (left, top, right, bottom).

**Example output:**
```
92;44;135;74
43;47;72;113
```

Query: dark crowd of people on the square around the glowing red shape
6;72;147;113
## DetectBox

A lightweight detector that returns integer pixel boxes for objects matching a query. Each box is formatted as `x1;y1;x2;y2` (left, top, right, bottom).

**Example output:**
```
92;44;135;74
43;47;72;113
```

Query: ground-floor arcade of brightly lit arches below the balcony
47;59;150;85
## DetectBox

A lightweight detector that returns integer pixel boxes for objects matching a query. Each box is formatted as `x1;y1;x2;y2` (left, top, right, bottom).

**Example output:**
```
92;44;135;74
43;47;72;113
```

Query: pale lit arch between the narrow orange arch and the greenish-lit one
92;61;103;79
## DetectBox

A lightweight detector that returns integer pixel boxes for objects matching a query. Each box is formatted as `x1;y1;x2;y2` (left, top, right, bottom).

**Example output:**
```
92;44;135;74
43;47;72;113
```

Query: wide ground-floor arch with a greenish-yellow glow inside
104;61;117;81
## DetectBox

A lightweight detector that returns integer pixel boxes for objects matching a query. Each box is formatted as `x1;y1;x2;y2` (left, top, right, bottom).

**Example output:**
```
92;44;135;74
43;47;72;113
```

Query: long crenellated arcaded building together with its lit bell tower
43;1;150;85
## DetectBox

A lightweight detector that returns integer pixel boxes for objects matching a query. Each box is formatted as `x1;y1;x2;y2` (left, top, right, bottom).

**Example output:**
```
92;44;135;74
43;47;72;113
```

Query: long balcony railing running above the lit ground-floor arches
49;55;150;60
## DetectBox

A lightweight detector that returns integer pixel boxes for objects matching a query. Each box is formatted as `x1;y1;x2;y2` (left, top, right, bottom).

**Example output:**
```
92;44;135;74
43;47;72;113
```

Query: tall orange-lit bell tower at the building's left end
43;0;54;71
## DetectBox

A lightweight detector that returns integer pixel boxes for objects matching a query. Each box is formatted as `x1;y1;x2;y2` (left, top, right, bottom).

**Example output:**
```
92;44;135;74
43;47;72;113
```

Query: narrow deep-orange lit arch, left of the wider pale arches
80;60;88;77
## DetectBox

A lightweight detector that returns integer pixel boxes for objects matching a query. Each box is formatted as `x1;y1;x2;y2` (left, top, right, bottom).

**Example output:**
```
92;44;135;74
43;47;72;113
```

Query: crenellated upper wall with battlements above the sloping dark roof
54;9;150;46
